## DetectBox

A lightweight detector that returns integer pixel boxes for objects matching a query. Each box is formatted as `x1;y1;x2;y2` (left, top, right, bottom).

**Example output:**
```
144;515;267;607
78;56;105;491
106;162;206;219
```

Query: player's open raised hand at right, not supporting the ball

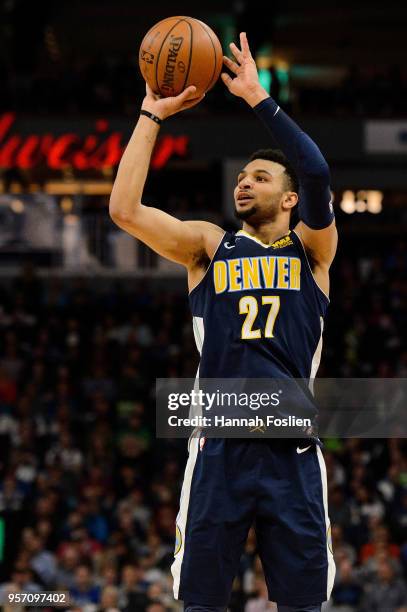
221;32;269;106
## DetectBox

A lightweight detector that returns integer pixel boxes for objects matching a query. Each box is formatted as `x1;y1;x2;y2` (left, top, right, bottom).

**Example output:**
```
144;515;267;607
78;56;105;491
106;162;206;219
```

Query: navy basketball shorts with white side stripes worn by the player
171;437;335;606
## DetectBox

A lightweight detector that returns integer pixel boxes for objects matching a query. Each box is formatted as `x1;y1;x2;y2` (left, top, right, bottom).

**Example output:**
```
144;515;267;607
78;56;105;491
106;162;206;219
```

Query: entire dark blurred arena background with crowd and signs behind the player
0;0;407;612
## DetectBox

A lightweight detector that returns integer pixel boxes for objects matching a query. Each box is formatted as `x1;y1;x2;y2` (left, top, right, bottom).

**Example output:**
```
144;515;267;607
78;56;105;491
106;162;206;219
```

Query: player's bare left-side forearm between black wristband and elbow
109;116;160;218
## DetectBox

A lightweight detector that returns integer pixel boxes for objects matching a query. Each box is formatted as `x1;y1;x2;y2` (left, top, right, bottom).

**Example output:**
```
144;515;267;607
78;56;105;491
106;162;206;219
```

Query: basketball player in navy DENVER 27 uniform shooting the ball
110;33;337;612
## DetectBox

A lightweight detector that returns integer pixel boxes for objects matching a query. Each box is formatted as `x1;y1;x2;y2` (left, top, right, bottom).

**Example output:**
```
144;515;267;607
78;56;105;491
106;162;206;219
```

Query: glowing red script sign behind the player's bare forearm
0;113;189;170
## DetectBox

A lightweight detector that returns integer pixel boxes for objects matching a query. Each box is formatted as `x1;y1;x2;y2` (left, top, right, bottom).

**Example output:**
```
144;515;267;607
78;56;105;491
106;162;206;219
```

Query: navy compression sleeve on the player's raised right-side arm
253;98;334;229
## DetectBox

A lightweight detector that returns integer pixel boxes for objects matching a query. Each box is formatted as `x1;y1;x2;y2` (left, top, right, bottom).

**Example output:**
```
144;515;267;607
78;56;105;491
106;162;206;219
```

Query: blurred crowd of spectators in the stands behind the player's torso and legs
0;237;407;612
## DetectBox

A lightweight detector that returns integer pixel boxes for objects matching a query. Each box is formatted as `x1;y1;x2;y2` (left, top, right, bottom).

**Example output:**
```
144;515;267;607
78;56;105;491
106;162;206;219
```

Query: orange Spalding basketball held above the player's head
139;17;223;97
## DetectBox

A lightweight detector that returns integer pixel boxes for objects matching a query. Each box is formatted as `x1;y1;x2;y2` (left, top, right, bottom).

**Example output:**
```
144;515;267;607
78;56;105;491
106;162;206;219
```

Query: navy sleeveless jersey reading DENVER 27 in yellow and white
189;230;329;378
